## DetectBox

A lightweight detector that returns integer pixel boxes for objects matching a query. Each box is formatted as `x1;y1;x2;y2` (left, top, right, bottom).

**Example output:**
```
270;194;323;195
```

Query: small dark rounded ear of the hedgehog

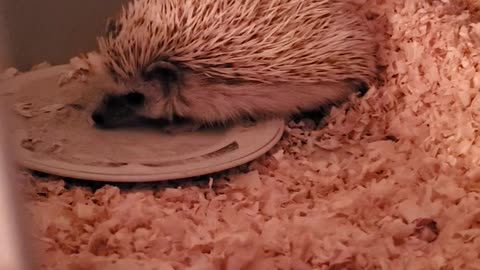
143;61;181;96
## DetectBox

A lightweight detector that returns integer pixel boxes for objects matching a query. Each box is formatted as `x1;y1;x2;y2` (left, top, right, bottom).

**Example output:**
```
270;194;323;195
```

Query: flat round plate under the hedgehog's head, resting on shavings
0;66;284;182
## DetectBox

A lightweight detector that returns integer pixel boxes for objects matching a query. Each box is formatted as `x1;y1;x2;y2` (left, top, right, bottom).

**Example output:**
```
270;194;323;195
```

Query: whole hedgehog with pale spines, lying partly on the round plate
90;0;376;132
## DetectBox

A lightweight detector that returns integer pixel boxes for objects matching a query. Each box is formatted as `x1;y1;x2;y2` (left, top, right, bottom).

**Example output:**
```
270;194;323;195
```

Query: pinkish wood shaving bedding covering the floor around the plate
2;0;480;270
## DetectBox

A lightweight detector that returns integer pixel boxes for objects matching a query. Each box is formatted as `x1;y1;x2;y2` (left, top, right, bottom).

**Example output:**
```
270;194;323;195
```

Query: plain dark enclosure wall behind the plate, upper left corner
0;0;127;71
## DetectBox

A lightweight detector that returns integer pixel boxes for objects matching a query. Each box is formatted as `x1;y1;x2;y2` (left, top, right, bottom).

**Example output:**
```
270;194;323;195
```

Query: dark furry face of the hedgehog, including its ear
91;61;187;128
